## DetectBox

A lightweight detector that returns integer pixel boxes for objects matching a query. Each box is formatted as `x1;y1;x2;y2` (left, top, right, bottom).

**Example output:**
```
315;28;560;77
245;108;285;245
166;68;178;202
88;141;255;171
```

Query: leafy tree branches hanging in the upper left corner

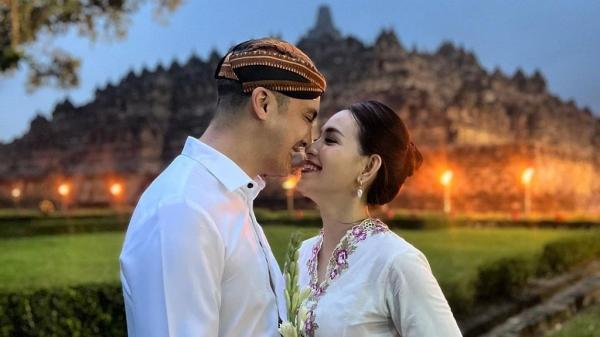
0;0;181;90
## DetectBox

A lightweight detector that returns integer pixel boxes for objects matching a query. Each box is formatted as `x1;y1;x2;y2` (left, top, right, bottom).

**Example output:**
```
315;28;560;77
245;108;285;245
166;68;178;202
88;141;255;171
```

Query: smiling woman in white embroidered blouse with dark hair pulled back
298;101;461;337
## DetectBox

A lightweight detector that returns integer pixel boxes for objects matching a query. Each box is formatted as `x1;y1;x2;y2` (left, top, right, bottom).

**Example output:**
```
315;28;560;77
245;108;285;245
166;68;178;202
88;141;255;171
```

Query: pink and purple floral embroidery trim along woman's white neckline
303;218;389;337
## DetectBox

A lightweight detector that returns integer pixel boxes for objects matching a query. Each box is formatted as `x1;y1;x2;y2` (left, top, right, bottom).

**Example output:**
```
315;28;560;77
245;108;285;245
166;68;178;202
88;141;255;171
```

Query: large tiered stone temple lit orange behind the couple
0;7;600;214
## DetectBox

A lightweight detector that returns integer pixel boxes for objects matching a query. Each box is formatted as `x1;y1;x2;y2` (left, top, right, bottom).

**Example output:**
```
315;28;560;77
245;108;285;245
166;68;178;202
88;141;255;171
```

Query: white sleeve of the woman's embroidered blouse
385;251;462;337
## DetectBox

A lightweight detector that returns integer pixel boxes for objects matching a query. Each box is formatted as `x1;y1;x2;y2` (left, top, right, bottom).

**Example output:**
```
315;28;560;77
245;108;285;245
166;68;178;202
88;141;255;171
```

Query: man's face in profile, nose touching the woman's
267;94;321;176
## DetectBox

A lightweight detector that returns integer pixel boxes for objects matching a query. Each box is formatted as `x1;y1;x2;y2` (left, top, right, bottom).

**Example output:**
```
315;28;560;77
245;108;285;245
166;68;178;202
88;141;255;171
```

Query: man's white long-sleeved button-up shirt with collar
120;137;286;337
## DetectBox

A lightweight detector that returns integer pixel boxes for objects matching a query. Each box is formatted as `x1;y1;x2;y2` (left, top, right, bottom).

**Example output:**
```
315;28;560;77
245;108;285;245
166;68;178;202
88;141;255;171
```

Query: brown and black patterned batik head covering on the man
215;38;327;99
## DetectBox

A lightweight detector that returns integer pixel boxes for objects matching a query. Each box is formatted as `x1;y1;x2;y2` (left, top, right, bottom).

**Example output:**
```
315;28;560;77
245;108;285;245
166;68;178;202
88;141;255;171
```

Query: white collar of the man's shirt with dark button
181;137;265;196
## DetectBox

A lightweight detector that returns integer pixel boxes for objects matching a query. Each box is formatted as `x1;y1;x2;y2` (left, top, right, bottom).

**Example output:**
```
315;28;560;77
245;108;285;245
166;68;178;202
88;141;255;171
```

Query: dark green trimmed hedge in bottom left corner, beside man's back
0;284;127;337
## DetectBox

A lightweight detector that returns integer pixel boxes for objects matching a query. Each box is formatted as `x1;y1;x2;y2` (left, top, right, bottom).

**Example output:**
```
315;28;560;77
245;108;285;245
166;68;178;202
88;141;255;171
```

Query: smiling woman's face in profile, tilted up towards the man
297;110;368;203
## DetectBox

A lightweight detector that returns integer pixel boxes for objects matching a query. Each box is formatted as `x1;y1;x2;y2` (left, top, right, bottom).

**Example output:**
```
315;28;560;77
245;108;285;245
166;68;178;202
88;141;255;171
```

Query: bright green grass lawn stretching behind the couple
0;226;589;290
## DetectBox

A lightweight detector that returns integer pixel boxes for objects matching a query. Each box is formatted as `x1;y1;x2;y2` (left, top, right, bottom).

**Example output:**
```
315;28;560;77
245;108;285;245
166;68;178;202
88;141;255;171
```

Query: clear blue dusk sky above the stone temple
0;0;600;142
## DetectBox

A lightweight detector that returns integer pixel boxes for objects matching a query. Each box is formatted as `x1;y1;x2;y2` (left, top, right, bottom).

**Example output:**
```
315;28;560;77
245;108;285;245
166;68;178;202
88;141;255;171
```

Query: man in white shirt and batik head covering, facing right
120;39;326;337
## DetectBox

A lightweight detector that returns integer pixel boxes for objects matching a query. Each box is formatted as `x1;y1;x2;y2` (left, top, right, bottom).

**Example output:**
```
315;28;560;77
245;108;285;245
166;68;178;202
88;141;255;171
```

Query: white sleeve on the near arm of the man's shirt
159;204;225;337
